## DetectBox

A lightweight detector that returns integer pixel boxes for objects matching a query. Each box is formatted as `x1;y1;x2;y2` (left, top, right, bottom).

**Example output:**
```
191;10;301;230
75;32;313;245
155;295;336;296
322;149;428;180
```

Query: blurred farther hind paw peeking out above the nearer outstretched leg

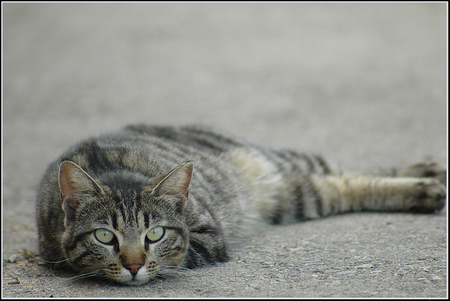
397;161;447;185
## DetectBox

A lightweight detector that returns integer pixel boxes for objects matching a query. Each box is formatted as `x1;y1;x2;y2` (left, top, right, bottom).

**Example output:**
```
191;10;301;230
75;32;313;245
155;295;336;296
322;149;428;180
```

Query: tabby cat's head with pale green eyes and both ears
59;161;193;285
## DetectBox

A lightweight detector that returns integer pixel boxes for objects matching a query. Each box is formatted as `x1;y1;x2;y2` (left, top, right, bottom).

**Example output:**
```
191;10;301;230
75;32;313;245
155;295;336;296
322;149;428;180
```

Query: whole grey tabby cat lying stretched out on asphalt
37;125;446;285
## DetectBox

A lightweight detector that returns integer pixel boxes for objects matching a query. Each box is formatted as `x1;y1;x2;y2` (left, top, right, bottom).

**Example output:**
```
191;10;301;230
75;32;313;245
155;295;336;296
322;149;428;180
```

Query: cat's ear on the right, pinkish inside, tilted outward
151;161;194;213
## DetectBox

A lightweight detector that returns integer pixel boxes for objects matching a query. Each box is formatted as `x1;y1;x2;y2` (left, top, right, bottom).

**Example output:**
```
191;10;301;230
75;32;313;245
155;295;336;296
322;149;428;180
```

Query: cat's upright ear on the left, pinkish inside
58;161;103;219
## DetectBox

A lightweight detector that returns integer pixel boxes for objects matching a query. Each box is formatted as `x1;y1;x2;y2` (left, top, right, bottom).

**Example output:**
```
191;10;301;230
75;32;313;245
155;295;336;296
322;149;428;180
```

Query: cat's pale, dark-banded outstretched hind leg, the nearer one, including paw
305;175;446;217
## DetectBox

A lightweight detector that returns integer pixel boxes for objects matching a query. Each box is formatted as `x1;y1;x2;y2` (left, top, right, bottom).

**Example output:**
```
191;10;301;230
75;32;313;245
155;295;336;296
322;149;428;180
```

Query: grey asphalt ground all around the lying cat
2;2;448;298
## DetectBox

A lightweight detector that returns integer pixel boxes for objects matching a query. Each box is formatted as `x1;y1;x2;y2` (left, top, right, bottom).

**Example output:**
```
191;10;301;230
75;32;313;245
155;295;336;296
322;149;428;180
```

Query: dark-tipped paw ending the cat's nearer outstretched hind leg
410;179;447;213
